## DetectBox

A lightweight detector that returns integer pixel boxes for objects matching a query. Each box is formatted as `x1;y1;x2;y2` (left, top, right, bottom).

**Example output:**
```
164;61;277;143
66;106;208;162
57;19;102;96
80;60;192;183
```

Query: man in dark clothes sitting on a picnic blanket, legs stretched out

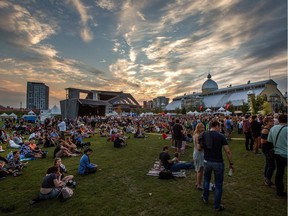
159;146;193;172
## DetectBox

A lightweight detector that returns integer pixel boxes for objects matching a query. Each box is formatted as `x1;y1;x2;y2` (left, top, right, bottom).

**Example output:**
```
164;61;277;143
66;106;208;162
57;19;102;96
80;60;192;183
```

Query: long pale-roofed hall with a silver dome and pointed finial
166;74;287;112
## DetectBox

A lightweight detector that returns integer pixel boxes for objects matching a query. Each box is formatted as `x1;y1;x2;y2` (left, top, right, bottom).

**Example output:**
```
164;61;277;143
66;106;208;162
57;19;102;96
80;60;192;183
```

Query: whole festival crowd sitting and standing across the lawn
0;114;287;208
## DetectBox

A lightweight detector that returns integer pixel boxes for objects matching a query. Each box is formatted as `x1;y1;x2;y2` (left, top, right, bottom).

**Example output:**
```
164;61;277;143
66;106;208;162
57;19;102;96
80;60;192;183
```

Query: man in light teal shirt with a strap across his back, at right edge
267;114;287;196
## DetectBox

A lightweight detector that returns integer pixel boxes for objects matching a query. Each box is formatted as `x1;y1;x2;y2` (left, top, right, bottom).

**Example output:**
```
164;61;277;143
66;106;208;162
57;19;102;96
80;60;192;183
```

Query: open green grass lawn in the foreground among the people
0;131;287;216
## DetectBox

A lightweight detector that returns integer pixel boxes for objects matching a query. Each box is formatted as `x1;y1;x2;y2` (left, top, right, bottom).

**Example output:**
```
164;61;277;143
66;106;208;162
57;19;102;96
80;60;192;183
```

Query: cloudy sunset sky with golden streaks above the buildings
0;0;287;108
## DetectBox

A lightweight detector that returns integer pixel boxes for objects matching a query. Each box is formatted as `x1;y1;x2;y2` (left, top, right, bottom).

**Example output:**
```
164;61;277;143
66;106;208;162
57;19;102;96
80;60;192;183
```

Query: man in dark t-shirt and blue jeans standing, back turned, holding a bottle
197;121;234;211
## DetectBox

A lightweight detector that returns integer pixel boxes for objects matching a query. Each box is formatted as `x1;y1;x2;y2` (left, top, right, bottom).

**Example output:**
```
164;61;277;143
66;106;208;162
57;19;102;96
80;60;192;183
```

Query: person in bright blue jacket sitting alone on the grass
78;148;98;176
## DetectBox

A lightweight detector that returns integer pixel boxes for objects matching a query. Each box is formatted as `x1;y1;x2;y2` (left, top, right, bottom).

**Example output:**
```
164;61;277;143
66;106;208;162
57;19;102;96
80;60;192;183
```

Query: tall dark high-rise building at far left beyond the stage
26;82;49;110
